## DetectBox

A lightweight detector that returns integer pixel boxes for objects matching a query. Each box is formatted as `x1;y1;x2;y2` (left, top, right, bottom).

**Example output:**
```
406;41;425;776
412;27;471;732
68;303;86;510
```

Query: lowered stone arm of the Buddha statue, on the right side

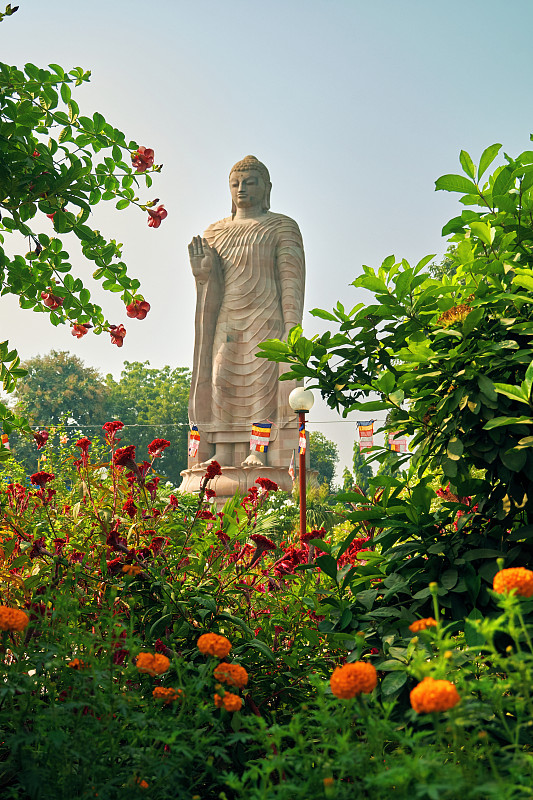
276;217;305;336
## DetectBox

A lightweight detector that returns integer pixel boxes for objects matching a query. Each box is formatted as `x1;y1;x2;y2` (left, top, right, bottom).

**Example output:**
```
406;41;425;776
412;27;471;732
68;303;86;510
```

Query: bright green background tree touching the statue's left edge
106;361;191;484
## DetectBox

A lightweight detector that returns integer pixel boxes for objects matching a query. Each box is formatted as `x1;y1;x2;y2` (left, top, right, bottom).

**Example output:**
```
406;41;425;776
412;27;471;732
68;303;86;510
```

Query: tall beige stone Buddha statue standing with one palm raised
180;156;305;496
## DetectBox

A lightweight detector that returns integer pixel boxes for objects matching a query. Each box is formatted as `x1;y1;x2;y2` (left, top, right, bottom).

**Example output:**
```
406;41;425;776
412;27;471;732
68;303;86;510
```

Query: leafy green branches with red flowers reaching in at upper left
0;8;162;458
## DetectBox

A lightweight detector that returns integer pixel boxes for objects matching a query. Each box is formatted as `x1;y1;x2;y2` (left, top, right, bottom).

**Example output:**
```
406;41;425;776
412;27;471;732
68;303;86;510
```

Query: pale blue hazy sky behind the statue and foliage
0;0;533;471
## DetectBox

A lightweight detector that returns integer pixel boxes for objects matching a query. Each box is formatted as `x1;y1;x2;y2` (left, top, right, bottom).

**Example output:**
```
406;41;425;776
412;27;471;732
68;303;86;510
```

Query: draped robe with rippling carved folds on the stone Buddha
190;211;305;462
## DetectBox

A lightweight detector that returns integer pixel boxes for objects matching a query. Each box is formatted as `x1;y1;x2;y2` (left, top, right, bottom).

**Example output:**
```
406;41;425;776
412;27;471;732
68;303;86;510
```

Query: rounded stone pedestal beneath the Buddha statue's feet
179;464;293;509
